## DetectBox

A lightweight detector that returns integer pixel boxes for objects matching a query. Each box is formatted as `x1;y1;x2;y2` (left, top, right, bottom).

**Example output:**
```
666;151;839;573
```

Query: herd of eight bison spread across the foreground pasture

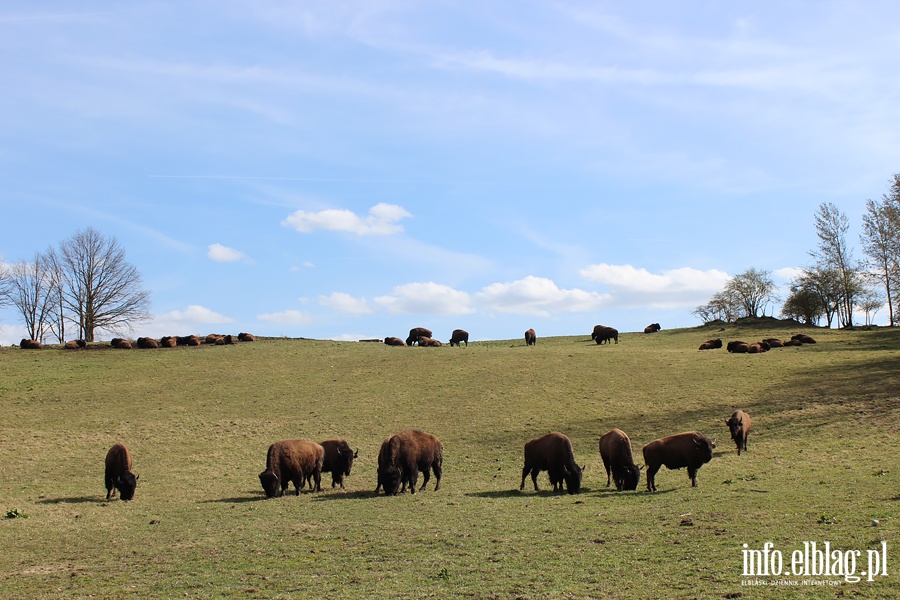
104;410;751;500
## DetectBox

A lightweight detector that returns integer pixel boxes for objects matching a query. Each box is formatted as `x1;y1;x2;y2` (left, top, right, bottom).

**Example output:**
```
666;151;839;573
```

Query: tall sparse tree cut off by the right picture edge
859;173;900;327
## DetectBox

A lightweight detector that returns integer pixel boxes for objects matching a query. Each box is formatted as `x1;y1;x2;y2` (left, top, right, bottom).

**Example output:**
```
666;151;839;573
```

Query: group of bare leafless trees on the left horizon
0;227;150;343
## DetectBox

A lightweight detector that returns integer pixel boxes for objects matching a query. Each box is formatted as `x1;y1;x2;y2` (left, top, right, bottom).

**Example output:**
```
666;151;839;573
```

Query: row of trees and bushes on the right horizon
691;173;900;328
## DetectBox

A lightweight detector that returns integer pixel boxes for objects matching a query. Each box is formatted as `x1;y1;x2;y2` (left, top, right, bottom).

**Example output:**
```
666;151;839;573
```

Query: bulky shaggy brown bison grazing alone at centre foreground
375;429;444;496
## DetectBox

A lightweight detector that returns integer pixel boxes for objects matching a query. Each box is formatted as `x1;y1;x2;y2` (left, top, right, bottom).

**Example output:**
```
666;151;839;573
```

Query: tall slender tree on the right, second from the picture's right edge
810;202;864;327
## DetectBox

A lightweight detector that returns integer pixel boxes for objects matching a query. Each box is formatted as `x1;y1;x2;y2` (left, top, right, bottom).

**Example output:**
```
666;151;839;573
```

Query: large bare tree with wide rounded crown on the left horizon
56;227;150;342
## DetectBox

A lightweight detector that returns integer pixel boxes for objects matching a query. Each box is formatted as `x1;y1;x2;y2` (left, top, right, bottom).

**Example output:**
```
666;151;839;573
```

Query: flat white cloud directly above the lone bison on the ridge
477;275;610;317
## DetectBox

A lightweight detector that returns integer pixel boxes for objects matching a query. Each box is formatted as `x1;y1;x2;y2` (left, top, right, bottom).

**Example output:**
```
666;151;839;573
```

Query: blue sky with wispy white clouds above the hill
0;0;900;345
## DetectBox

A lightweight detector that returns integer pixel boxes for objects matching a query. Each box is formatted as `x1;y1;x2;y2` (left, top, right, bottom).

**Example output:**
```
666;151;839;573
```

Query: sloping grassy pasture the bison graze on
0;323;900;598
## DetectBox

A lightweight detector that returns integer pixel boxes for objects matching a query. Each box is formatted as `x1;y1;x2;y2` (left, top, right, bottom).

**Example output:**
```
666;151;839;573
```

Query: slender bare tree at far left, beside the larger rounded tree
10;253;58;343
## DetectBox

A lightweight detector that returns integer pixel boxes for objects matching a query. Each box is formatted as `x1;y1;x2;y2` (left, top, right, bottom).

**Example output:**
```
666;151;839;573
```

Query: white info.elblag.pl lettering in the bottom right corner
742;541;888;585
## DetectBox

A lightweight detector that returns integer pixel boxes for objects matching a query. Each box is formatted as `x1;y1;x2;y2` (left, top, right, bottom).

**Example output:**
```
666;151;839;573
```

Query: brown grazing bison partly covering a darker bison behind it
259;440;325;498
